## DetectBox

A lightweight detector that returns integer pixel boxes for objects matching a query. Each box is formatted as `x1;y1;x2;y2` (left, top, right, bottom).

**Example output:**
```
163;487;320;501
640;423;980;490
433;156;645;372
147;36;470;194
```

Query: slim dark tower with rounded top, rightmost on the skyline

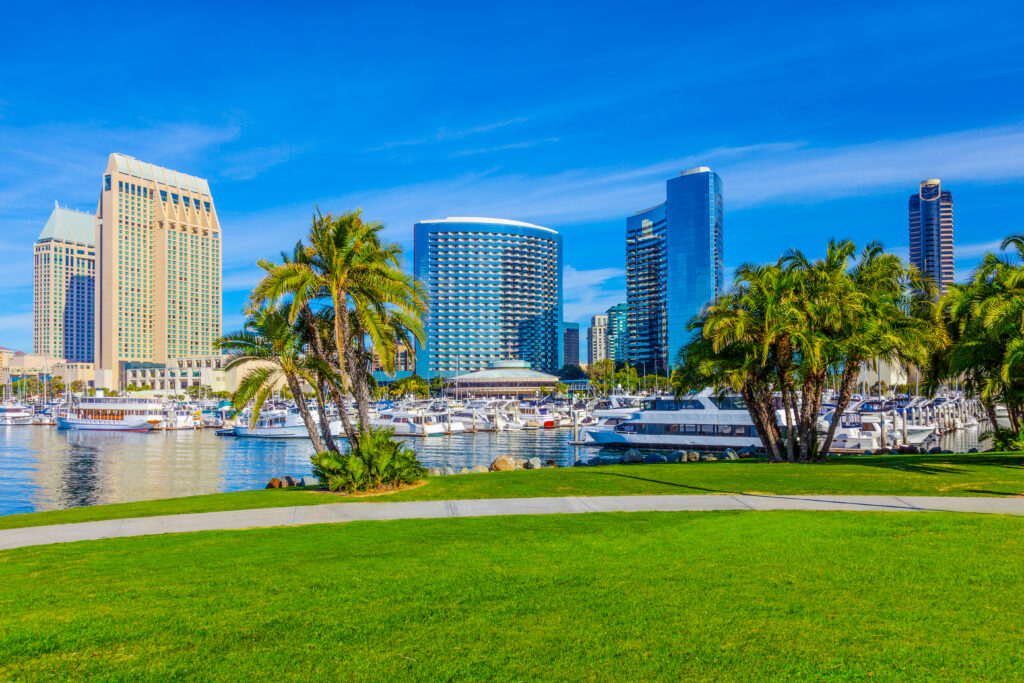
910;178;953;293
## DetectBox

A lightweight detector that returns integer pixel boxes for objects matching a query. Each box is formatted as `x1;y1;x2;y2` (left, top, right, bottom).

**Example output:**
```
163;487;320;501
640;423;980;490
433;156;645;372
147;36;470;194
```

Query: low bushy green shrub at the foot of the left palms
311;429;427;494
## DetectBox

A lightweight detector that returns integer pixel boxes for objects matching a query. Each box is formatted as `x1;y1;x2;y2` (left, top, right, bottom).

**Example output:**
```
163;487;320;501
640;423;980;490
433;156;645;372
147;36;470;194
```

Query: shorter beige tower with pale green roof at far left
32;205;96;362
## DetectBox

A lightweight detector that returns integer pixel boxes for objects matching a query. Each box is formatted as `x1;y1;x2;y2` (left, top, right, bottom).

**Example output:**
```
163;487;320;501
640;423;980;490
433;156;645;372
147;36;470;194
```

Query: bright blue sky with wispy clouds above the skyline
0;2;1024;358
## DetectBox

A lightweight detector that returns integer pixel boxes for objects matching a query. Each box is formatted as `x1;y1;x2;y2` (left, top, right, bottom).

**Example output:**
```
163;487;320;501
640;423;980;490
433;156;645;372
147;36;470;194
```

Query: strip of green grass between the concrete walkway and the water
0;453;1024;528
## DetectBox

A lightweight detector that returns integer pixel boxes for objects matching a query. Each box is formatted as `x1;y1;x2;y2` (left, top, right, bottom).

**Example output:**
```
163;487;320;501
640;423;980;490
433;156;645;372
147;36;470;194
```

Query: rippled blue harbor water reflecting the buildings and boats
0;425;991;515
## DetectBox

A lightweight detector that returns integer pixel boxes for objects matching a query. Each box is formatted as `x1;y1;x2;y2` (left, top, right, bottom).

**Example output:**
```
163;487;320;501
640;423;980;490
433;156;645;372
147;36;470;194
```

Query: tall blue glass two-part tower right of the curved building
626;166;723;373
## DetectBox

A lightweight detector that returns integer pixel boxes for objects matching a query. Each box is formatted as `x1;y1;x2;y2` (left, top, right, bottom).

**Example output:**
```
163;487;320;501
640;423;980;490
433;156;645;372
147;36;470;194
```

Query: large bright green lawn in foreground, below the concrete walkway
0;512;1024;681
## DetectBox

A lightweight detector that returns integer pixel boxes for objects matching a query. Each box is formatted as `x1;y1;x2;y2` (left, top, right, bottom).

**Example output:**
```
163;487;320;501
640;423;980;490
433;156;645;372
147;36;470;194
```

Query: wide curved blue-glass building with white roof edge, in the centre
414;218;563;379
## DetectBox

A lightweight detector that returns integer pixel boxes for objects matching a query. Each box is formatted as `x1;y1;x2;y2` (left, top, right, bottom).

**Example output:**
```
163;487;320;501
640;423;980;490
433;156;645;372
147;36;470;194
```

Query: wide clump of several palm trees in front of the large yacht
673;241;941;462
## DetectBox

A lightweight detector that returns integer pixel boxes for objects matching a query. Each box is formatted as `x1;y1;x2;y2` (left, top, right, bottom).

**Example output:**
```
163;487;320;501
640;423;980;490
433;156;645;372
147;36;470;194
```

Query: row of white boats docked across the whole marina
0;389;983;452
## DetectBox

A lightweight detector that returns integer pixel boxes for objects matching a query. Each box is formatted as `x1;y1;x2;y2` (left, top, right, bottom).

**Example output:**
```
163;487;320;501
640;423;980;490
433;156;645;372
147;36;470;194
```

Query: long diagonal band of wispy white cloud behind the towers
224;126;1024;272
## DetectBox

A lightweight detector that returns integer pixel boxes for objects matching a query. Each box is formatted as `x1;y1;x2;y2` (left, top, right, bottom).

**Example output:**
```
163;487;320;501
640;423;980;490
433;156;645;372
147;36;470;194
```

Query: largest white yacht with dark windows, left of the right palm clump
590;389;761;451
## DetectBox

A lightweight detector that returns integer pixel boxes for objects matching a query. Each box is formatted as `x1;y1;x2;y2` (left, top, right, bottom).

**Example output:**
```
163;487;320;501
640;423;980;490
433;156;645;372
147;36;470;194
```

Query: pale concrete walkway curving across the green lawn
0;495;1024;550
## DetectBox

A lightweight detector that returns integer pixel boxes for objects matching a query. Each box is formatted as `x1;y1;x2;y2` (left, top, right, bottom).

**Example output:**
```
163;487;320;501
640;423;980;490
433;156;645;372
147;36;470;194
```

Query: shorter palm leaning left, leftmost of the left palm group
216;306;324;453
